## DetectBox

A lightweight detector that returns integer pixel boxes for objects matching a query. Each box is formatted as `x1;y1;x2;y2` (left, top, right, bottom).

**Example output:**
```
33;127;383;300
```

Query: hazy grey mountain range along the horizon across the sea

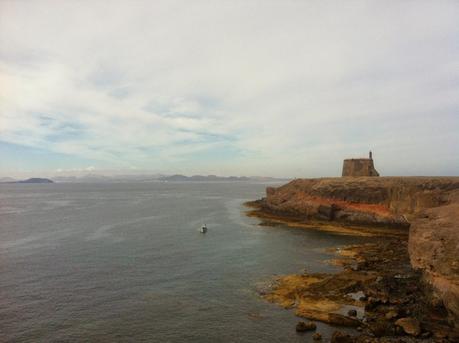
0;174;288;183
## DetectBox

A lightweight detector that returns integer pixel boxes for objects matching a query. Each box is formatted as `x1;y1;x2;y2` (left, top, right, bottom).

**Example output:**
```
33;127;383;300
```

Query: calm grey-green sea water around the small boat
0;182;366;342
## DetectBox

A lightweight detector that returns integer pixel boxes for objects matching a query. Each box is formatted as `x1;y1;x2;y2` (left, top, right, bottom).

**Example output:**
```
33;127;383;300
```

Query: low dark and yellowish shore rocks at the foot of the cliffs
262;238;459;343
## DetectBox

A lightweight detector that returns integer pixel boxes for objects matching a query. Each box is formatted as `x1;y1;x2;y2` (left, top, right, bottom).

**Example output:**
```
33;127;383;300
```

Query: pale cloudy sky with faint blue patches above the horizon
0;0;459;177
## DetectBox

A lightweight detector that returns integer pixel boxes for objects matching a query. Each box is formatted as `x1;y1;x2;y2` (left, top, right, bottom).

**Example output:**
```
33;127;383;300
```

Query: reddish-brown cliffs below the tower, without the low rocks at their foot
255;177;459;322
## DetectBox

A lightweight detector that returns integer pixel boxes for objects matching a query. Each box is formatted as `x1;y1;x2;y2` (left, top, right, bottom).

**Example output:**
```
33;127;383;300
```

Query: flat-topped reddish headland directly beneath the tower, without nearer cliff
255;177;459;222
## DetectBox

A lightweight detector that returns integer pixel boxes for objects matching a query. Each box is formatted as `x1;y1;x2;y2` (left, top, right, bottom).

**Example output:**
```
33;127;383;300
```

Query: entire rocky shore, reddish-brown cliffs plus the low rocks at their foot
247;178;459;342
